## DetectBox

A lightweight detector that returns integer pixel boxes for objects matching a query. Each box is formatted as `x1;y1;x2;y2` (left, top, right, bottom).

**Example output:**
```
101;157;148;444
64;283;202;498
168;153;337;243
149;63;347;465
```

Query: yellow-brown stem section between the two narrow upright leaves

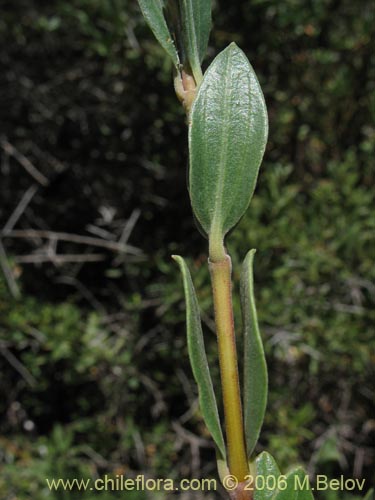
209;255;249;482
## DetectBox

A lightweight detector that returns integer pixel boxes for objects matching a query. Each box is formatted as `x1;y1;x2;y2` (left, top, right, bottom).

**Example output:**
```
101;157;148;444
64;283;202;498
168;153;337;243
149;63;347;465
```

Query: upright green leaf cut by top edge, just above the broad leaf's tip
180;0;212;83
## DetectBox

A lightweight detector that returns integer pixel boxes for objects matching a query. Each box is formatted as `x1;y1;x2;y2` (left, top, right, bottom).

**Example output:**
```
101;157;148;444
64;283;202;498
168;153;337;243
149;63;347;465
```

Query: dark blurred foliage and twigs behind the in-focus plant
0;0;375;500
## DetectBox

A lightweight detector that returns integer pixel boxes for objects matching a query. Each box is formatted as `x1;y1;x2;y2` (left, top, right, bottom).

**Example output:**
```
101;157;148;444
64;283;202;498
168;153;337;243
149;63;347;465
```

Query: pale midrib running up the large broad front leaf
210;51;230;244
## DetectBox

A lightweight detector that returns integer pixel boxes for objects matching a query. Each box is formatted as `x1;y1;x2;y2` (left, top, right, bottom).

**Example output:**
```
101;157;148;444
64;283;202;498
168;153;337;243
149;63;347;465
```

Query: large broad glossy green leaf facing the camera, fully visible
189;43;268;242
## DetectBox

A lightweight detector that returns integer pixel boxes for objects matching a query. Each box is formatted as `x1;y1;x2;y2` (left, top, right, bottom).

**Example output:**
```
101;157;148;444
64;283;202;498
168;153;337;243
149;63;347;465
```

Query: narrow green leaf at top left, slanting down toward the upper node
138;0;180;68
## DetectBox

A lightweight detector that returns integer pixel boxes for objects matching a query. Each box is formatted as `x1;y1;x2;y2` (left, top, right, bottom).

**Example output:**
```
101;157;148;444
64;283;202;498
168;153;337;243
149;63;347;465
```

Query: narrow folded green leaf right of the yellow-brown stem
241;249;268;458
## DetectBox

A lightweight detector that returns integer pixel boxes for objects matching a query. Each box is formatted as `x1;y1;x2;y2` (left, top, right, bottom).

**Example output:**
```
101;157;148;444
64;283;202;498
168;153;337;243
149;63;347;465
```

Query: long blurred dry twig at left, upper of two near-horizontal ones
0;229;142;255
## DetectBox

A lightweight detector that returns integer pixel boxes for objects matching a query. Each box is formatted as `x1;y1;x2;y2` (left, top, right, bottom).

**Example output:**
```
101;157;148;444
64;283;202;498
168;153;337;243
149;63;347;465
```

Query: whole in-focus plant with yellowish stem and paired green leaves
138;0;313;500
